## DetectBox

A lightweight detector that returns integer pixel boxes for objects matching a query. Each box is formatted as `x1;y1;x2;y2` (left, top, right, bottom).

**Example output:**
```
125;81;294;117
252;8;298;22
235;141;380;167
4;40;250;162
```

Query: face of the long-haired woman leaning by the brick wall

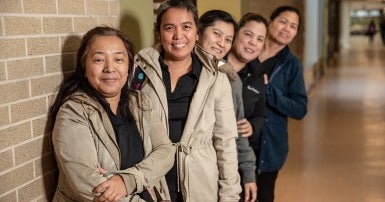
85;36;129;101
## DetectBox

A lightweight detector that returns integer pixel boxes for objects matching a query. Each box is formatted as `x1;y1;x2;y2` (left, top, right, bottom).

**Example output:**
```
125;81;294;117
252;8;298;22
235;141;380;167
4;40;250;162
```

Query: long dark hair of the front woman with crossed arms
50;26;134;126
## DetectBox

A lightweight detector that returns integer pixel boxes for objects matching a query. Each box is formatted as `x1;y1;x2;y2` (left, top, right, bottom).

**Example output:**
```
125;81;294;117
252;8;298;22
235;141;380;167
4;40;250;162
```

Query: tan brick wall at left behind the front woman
0;0;120;202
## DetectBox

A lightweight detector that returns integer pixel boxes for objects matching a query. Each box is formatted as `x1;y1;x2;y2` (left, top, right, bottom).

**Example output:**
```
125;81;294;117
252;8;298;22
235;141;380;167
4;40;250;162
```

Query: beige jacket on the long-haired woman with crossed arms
52;91;175;201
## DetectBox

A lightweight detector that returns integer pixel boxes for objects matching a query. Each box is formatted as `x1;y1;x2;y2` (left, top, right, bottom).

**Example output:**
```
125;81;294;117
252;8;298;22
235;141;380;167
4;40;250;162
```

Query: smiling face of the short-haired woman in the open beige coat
159;8;198;61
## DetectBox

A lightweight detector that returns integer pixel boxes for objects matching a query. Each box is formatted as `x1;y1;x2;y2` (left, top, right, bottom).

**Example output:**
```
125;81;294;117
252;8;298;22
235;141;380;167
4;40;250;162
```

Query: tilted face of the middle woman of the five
198;20;234;59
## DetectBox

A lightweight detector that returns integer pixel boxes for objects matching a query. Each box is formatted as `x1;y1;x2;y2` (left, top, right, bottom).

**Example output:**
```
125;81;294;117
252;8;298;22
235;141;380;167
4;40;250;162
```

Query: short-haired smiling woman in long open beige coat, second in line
134;0;241;202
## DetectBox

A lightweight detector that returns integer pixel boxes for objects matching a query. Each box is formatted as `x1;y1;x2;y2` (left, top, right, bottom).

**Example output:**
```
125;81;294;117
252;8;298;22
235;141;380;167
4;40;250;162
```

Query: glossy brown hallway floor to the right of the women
275;34;385;202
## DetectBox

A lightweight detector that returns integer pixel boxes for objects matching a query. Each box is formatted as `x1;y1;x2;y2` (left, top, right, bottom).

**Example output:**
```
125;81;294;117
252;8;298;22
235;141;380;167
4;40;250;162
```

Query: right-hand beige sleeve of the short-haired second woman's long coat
213;74;242;201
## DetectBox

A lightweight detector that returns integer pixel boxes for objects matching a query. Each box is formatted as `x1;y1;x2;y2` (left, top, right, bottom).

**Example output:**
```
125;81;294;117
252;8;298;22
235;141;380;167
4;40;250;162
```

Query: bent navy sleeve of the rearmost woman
265;59;308;119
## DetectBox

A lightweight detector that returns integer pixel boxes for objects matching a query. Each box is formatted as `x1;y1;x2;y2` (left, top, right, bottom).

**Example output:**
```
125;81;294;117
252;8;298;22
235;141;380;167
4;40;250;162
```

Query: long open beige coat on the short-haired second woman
135;47;241;202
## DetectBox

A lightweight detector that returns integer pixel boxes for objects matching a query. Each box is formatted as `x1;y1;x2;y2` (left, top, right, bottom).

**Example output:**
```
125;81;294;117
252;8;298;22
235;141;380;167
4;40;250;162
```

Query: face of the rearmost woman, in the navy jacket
269;11;299;45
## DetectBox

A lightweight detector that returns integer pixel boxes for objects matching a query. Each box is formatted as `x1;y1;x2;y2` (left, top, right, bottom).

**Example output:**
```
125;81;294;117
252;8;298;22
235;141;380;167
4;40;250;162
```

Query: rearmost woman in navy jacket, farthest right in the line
255;6;308;202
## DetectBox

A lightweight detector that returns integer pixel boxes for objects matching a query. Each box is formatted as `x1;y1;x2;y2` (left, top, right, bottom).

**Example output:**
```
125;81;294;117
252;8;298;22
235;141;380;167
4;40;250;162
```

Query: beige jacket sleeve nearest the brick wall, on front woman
52;102;107;200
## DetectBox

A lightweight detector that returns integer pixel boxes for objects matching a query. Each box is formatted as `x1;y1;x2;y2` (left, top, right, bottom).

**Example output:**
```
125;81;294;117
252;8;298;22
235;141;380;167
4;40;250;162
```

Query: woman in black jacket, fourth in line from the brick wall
227;13;267;200
